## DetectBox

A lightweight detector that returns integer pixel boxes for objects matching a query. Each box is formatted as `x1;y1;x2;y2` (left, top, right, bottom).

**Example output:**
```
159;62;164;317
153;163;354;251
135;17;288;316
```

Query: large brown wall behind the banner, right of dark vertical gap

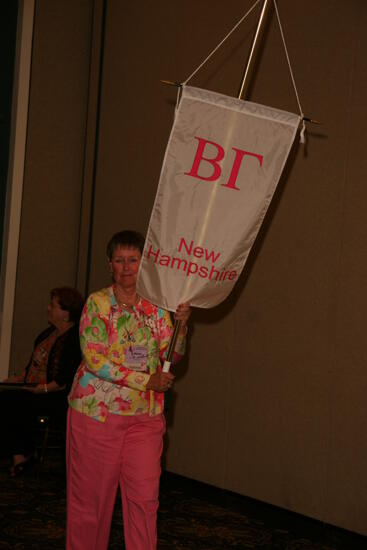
90;0;367;534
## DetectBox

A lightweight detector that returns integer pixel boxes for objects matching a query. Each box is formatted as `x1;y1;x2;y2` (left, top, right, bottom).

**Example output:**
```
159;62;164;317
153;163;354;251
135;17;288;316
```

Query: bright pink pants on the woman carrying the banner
66;409;165;550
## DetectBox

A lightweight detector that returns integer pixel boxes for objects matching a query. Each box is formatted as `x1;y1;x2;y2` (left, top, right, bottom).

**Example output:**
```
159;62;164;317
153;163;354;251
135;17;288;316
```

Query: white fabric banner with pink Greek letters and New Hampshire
137;86;300;311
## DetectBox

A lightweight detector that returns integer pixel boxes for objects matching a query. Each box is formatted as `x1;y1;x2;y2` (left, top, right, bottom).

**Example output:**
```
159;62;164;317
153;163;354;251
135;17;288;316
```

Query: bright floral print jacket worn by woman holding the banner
69;286;185;422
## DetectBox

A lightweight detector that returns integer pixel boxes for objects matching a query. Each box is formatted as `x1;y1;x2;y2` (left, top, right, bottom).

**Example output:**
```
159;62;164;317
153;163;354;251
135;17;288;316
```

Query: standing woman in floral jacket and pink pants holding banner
66;231;191;550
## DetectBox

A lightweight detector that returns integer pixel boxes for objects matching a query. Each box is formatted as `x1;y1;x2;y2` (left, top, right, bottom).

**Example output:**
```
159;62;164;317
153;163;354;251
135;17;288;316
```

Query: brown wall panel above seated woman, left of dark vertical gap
11;0;92;376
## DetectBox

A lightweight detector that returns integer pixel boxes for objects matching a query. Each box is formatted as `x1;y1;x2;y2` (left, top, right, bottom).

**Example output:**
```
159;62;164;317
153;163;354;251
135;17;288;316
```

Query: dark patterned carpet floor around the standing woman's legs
0;449;367;550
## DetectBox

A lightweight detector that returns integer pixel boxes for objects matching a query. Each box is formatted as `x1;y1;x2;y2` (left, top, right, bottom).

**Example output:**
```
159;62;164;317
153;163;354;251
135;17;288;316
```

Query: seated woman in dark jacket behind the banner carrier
0;287;84;476
